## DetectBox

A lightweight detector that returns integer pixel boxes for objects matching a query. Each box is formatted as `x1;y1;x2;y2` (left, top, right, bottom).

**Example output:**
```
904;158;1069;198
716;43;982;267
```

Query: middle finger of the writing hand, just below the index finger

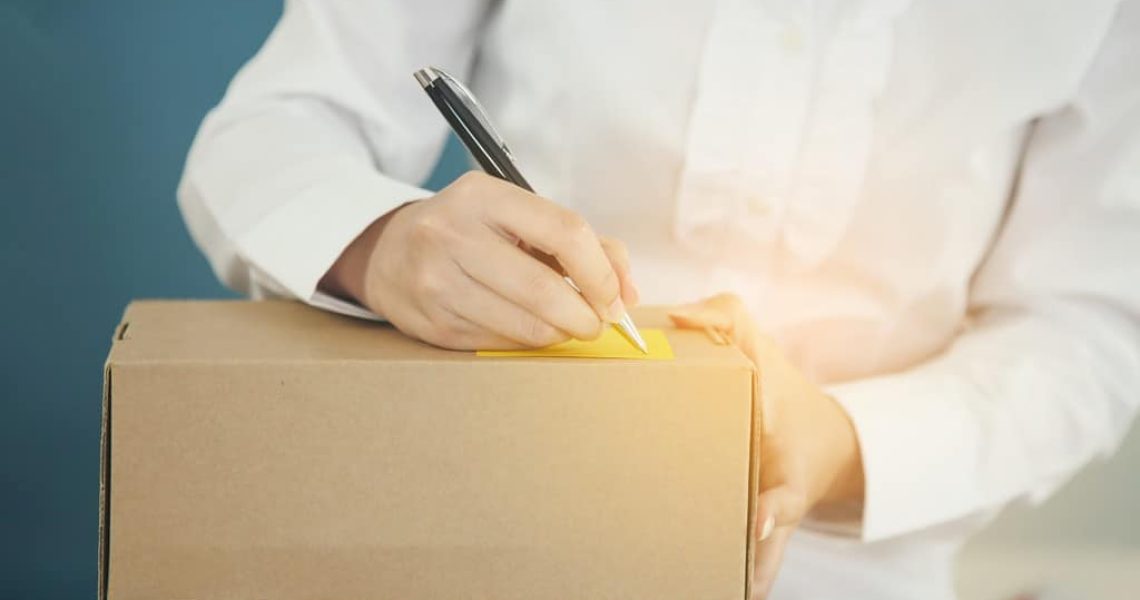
455;240;602;340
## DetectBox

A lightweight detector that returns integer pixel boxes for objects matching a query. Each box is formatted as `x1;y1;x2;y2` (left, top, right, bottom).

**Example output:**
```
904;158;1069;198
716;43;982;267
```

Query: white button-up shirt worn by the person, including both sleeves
179;0;1140;598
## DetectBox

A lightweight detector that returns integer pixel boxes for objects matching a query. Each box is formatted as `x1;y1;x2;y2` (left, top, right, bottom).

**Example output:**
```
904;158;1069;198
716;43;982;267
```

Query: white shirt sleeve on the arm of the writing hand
178;0;487;317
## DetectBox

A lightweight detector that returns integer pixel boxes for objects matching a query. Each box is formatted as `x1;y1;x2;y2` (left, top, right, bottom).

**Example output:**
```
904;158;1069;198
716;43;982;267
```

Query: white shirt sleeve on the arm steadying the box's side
829;2;1140;541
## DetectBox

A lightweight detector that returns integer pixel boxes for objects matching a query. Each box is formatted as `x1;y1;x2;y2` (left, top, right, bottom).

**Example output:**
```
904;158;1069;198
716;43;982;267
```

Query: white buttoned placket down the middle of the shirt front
675;0;811;256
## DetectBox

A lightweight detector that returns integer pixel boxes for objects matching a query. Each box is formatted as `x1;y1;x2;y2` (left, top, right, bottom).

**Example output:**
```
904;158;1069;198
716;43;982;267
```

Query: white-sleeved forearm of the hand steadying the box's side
829;303;1140;541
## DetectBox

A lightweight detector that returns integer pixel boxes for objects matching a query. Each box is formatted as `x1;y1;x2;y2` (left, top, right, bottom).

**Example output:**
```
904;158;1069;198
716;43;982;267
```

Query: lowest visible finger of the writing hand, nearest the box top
447;266;569;350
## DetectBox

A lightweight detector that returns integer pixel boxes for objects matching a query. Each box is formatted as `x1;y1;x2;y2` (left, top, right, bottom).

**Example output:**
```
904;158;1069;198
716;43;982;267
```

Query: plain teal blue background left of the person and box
0;0;463;599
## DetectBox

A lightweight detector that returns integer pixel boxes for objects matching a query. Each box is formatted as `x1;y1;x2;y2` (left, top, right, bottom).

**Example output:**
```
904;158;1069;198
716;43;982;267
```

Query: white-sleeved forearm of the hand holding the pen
179;104;430;301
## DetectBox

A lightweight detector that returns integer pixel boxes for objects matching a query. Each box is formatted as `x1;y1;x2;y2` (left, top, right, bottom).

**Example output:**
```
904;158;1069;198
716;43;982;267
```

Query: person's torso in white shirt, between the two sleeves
472;0;1115;598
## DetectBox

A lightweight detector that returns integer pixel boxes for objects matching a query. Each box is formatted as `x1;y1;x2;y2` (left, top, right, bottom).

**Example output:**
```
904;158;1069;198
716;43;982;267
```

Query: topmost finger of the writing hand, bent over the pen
487;190;626;322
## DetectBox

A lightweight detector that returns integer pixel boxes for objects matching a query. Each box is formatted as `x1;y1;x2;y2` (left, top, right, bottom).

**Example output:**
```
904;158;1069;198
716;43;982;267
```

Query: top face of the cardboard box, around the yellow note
109;300;750;368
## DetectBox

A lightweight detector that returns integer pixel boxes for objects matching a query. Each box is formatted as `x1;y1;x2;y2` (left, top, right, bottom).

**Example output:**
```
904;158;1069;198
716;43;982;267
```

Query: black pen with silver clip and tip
415;66;649;354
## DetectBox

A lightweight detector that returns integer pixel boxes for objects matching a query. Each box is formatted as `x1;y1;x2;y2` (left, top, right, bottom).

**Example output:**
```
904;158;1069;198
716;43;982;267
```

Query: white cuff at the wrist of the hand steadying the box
828;368;978;542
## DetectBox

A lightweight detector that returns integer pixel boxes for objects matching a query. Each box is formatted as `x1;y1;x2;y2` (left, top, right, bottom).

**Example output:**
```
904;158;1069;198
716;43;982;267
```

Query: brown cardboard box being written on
99;301;759;600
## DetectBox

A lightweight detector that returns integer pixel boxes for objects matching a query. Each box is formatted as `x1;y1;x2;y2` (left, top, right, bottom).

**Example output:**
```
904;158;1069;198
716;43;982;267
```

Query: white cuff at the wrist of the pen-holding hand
237;163;432;319
